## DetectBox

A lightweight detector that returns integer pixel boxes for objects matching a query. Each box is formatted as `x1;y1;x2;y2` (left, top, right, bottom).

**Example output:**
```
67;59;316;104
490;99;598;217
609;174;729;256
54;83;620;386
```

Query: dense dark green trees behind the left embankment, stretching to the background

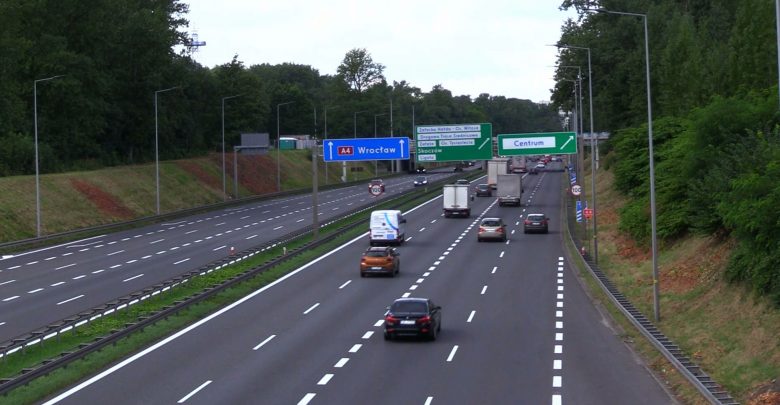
0;0;560;176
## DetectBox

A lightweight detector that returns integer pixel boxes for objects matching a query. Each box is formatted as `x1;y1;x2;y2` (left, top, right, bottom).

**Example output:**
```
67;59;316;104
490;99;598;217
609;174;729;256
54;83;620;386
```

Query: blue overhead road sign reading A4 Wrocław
322;137;409;162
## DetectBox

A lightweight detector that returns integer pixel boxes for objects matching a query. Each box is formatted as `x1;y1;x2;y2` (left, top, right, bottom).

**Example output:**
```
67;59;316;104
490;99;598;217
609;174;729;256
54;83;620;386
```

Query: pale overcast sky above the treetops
185;0;575;102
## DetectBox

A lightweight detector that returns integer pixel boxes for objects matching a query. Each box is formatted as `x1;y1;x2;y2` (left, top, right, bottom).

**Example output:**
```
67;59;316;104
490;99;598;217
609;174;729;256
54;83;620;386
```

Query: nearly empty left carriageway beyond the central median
0;173;452;342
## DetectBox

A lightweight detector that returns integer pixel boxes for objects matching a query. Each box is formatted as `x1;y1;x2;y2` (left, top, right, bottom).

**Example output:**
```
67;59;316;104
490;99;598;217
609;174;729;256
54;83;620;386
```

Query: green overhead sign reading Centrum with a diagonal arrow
498;132;577;156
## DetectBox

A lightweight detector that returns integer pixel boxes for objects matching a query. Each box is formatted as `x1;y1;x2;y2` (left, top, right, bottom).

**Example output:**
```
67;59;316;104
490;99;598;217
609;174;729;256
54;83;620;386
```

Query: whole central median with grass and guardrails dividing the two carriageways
0;168;482;395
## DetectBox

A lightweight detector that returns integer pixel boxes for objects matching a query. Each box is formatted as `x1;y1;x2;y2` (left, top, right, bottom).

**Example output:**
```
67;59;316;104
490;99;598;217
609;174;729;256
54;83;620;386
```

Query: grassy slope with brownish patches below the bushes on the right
568;162;780;404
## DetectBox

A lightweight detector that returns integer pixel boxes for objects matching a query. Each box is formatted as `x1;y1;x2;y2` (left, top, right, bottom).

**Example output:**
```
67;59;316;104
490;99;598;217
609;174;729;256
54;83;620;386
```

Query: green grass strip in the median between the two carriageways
0;183;438;404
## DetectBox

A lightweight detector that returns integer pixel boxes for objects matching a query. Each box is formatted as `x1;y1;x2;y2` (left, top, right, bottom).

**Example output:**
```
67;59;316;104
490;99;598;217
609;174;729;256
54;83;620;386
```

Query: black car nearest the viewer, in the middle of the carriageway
385;298;441;340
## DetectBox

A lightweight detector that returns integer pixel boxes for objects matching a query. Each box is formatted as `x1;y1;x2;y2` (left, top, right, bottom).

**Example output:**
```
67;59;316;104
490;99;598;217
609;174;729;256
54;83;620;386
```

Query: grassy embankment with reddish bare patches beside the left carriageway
0;150;381;243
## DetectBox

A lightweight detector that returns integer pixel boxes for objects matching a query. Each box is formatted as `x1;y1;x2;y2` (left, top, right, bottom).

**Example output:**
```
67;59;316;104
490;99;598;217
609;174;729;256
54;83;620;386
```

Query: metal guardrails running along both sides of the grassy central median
0;173;461;394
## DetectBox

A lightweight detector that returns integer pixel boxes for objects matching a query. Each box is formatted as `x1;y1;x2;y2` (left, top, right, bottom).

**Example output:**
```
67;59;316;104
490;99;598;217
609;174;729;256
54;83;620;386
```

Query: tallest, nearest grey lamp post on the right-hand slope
596;9;660;322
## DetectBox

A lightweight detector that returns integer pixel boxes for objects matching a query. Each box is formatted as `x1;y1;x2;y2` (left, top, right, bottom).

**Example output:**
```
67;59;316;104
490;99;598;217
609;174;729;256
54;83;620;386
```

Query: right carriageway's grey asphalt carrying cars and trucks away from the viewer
41;172;675;405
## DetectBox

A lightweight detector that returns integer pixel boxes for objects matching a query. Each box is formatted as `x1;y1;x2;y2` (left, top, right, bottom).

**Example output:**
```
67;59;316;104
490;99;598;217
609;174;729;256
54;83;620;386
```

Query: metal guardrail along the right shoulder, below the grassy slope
563;191;739;405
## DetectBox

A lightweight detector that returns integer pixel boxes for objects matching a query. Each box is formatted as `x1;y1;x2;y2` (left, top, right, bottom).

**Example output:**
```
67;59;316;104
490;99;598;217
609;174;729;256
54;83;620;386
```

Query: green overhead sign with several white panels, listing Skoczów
414;124;493;162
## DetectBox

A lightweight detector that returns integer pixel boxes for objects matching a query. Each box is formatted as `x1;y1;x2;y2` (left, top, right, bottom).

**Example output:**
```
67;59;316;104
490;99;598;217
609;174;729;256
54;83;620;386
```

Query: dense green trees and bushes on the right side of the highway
553;0;780;304
